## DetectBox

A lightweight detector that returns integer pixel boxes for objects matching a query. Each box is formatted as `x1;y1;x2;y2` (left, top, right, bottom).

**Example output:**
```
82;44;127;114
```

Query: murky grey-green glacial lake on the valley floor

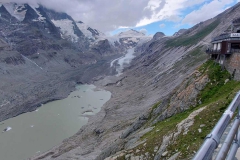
0;84;111;160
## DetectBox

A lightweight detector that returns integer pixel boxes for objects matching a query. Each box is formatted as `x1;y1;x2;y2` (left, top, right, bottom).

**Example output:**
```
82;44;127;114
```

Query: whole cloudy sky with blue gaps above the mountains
0;0;240;35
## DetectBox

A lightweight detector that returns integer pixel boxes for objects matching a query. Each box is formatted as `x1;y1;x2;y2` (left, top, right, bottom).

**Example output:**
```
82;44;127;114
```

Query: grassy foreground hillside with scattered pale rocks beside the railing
113;60;240;160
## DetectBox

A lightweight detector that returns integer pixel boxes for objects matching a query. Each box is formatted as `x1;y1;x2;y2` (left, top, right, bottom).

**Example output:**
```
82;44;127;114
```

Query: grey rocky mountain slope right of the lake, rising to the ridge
29;1;240;160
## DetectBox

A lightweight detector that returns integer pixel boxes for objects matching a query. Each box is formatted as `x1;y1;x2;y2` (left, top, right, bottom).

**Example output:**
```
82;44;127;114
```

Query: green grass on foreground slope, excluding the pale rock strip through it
119;61;240;159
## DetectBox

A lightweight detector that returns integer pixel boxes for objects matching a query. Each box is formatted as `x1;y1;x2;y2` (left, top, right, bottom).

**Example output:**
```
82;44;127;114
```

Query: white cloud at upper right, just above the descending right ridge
182;0;234;25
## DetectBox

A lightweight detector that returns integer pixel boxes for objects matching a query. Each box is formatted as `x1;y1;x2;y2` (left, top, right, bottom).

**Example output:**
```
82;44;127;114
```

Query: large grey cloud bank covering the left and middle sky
0;0;152;32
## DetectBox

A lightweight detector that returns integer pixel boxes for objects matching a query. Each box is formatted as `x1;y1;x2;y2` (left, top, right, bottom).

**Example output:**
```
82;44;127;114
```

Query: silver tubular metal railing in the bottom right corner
193;91;240;160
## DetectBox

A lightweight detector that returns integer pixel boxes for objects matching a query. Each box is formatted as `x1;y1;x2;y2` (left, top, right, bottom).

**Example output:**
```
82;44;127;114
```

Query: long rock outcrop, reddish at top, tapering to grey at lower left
114;67;209;150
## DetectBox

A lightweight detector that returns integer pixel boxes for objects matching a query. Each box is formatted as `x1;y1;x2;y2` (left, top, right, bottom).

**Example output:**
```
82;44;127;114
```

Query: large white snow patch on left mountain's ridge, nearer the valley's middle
52;19;78;42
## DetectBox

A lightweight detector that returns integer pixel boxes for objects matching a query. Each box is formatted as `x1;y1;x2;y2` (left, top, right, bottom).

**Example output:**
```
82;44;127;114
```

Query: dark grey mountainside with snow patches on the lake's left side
0;3;150;121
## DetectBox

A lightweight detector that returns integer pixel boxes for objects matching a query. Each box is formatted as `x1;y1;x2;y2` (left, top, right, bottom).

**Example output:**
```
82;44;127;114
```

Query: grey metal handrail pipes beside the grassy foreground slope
193;91;240;160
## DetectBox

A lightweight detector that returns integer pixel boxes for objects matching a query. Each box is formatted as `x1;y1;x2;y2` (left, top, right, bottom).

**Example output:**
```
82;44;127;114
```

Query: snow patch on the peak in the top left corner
3;3;27;21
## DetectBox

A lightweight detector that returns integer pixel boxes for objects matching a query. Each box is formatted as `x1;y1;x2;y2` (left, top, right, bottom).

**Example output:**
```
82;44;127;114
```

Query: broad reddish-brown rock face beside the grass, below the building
153;70;209;123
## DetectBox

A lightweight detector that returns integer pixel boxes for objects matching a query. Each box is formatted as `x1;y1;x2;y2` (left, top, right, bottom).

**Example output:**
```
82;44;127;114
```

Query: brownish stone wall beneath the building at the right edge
224;53;240;80
